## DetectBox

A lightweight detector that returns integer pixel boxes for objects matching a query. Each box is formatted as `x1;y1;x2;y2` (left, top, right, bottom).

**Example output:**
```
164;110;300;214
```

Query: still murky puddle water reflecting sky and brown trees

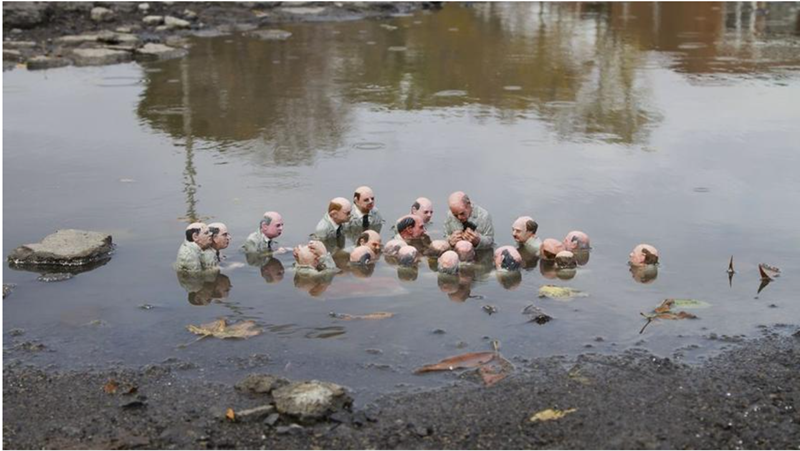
3;3;800;399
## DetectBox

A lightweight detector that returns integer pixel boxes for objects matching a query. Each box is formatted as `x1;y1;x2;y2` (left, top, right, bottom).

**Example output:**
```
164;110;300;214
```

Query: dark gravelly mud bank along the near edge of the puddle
3;331;800;449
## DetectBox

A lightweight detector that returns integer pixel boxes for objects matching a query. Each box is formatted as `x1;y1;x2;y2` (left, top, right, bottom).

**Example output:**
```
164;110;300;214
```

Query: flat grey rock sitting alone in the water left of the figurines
8;231;114;266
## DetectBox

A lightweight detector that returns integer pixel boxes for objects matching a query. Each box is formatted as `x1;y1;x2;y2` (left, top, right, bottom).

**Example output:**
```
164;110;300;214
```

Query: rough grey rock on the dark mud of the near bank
272;381;353;420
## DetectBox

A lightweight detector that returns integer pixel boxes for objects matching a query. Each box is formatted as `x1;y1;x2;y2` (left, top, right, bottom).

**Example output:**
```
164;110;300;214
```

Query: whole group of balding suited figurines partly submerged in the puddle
175;186;658;294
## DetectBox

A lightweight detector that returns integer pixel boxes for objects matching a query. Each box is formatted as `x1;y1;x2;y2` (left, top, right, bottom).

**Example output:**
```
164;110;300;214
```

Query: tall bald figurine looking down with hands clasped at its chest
444;191;494;249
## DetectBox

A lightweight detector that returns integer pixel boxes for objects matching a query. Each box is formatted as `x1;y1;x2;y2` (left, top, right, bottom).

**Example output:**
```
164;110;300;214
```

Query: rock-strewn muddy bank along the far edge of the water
3;2;440;70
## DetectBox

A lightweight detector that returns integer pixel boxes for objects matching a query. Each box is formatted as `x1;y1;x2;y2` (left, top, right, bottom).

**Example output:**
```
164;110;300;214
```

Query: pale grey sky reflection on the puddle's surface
3;2;800;400
